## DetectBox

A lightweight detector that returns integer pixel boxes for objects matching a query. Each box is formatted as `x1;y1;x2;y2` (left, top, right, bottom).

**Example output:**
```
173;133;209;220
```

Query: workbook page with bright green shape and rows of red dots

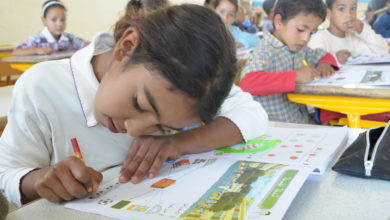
191;127;348;175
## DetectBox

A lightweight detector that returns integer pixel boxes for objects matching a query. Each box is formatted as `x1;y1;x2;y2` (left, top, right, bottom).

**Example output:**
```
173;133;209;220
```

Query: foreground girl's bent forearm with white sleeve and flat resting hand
119;86;268;183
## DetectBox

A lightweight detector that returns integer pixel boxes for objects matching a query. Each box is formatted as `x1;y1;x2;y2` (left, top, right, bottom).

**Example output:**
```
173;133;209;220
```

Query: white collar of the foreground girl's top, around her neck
69;32;115;127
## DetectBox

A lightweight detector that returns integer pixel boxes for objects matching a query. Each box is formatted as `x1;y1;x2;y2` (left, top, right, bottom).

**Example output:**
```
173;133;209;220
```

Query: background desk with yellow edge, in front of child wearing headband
2;51;74;72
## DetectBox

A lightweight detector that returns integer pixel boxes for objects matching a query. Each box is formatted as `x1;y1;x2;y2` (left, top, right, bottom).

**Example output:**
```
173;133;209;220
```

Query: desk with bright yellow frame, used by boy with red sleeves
287;85;390;128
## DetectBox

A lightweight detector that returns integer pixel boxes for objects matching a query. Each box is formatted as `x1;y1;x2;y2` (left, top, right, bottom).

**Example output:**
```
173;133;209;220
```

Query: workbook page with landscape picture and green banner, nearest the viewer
65;159;310;219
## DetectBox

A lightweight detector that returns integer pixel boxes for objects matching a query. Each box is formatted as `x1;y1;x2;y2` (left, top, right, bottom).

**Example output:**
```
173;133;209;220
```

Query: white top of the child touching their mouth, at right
308;23;389;63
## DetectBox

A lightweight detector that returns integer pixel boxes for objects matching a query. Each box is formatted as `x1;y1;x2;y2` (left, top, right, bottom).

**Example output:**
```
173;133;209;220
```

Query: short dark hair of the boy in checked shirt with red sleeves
274;0;326;22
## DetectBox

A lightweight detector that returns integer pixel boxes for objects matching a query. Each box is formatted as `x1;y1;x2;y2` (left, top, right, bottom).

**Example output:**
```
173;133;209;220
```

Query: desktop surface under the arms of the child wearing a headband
1;51;74;63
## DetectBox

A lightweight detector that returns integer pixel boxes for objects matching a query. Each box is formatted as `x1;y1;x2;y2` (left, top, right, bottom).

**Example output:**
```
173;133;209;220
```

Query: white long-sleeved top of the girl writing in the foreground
0;33;268;205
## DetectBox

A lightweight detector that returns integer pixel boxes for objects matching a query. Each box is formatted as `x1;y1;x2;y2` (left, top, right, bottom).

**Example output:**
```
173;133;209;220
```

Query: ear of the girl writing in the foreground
114;27;140;61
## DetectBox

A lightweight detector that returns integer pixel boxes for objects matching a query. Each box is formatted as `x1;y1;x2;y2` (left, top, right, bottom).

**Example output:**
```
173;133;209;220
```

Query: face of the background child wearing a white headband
42;7;66;40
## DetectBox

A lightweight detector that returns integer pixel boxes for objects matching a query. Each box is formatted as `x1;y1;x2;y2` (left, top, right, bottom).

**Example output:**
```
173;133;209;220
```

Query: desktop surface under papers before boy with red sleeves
293;85;390;99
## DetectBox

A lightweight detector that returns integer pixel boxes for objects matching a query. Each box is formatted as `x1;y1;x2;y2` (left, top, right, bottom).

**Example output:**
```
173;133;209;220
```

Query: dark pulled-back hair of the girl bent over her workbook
114;4;238;123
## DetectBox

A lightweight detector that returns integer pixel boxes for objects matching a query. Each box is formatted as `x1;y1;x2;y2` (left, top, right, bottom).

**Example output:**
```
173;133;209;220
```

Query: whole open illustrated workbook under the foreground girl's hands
65;127;347;219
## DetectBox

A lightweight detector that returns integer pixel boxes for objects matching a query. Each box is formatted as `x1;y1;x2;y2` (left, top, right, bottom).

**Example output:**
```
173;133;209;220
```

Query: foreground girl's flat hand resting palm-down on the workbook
119;135;182;183
